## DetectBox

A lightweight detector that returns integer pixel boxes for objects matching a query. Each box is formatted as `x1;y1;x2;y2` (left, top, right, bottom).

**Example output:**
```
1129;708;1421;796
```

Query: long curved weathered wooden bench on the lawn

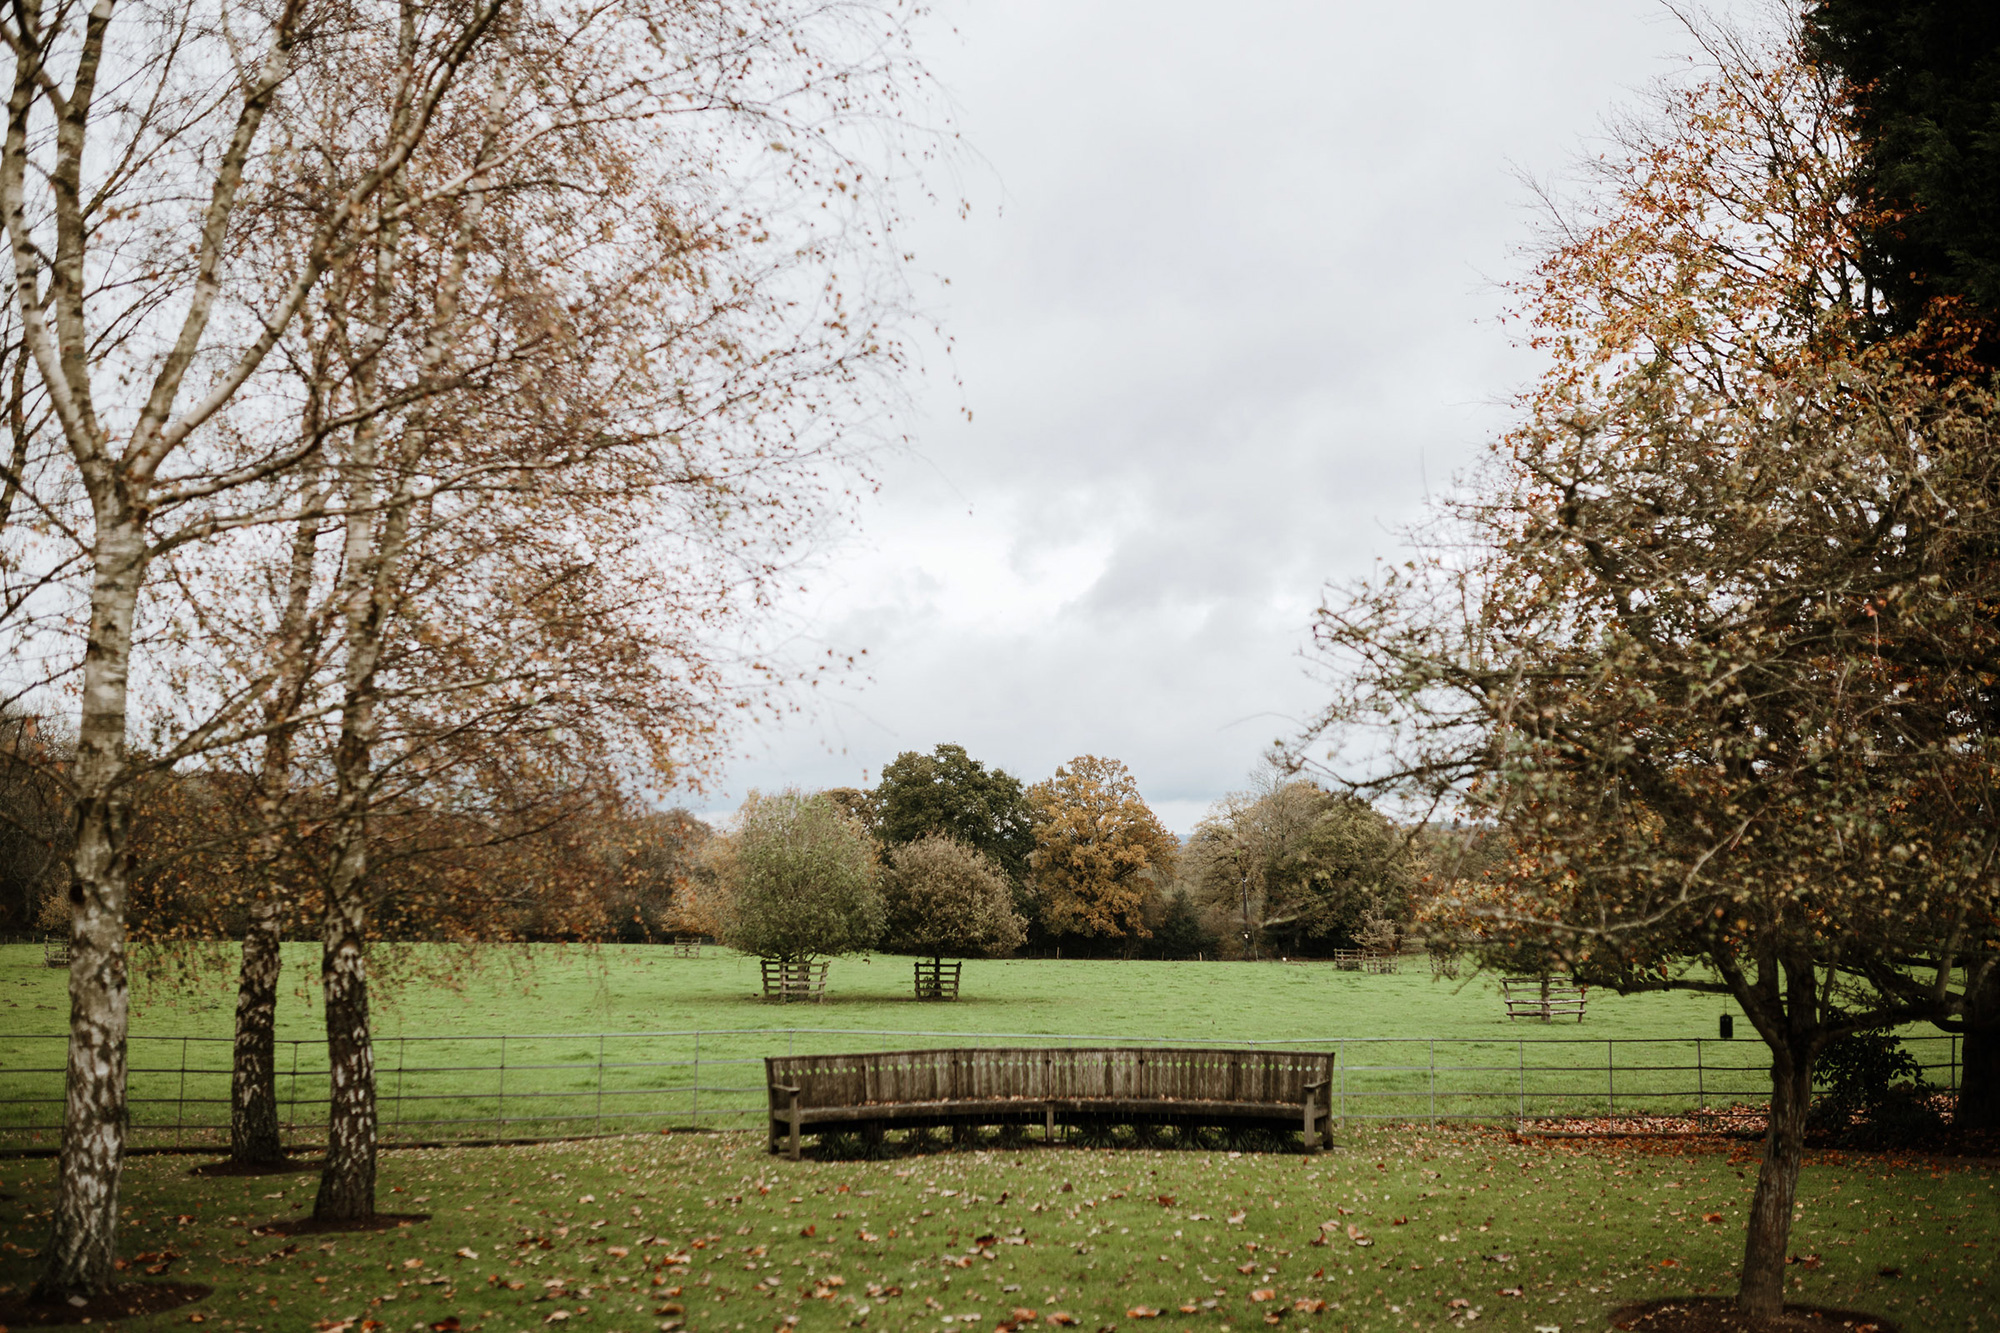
764;1047;1334;1161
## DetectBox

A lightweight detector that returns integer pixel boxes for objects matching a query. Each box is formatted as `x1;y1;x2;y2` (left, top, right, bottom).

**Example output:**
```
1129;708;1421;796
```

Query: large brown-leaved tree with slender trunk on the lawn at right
1316;13;2000;1319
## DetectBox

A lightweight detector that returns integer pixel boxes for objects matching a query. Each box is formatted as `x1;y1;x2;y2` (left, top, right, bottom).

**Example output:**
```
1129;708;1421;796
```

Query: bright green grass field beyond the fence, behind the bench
0;947;1954;1145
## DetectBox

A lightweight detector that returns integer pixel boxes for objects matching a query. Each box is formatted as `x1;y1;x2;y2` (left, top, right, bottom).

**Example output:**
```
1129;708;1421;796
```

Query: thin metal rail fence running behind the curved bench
0;1027;1958;1149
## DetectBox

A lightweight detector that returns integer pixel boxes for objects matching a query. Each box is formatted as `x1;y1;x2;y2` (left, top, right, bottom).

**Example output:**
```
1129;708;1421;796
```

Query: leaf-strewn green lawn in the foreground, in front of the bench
0;1129;2000;1333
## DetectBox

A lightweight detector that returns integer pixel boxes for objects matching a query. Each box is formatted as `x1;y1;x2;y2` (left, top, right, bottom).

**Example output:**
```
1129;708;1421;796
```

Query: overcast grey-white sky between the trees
700;0;1752;833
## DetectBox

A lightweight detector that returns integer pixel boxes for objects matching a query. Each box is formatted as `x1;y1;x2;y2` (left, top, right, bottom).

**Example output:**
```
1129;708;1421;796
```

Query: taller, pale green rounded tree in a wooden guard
716;789;882;963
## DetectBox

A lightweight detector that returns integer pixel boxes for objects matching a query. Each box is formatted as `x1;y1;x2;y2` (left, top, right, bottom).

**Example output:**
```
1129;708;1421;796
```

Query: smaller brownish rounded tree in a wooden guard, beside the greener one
882;833;1026;984
